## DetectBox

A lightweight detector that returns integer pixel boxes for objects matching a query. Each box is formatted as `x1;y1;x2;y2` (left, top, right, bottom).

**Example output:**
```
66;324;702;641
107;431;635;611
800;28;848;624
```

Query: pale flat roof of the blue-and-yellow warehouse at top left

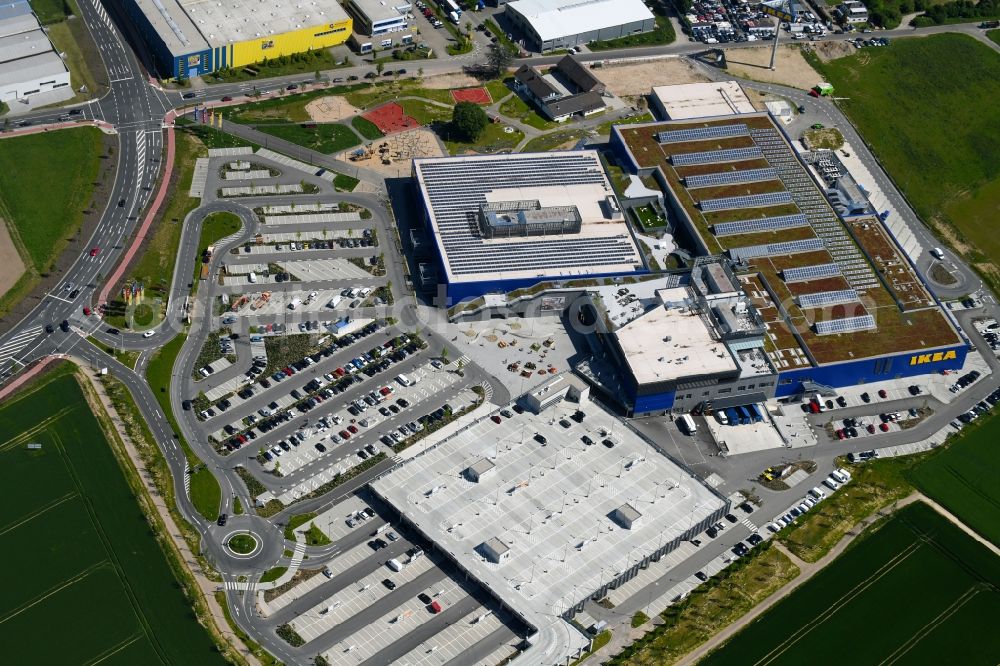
134;0;348;57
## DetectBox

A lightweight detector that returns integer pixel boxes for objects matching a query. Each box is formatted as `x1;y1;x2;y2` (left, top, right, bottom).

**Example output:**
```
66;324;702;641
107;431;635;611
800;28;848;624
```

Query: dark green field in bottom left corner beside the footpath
0;373;226;664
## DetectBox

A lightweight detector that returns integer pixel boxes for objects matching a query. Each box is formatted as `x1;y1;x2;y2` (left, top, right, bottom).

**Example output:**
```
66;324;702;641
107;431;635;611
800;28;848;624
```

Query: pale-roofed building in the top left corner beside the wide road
0;1;73;106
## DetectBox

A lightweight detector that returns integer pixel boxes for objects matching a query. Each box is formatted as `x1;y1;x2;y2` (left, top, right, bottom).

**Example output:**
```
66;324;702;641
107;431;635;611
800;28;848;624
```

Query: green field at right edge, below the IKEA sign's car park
910;416;1000;544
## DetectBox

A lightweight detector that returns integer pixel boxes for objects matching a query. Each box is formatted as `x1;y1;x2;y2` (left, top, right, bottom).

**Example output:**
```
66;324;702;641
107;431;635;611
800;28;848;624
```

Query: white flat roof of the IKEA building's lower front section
615;287;737;384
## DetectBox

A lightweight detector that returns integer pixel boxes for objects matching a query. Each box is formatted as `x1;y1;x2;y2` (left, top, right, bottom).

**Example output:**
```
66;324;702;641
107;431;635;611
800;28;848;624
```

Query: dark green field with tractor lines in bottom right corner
699;502;1000;666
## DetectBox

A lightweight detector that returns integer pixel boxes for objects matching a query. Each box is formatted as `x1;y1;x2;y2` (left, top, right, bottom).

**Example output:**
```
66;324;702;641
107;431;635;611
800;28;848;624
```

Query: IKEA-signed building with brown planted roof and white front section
595;113;969;414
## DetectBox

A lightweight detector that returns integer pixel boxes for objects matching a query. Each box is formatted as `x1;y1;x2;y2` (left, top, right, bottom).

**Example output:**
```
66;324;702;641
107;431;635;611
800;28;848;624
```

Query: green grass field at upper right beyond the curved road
817;34;1000;285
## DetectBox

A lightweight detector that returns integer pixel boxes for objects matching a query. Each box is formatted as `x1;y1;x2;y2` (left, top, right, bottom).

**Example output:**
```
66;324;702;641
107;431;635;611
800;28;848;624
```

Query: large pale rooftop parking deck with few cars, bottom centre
372;392;725;663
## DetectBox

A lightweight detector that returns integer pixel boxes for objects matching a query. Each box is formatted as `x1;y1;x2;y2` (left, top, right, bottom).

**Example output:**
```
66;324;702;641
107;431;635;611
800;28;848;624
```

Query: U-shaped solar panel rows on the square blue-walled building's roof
415;151;641;276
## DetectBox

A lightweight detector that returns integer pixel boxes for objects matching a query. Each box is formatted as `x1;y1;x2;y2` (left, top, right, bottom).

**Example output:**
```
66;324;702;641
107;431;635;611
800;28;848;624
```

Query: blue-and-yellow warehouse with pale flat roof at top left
124;0;352;78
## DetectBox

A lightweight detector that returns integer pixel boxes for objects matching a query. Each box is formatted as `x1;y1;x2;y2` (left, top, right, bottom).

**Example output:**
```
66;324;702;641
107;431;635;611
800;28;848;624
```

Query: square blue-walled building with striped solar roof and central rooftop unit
413;150;646;301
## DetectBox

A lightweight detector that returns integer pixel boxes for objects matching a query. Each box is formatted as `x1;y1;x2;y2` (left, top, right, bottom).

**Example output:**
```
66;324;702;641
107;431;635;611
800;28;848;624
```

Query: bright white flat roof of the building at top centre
507;0;655;42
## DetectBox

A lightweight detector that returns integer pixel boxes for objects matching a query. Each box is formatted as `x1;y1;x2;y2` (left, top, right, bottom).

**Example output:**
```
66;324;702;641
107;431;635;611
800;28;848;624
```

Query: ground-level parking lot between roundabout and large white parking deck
264;496;523;666
